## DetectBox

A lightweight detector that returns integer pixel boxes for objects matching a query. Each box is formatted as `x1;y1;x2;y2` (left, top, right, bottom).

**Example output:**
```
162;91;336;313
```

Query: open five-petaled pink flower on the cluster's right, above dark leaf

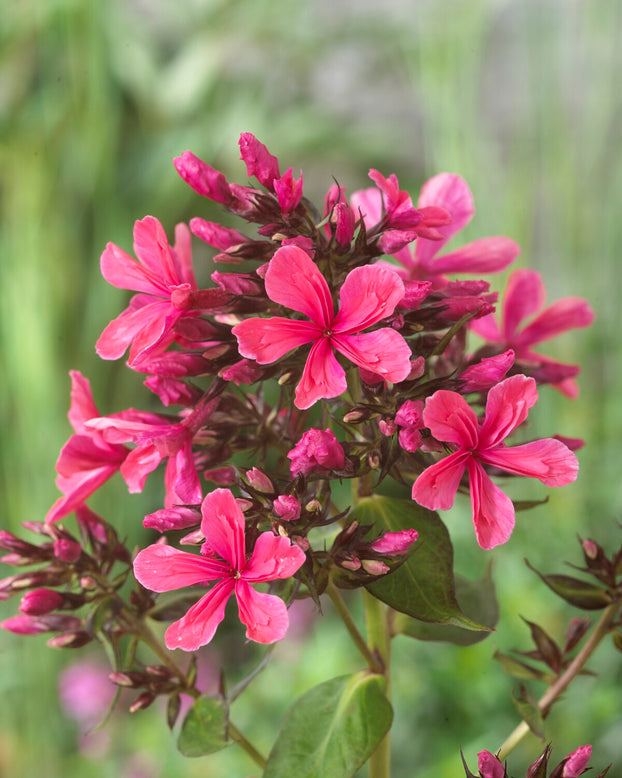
412;375;579;549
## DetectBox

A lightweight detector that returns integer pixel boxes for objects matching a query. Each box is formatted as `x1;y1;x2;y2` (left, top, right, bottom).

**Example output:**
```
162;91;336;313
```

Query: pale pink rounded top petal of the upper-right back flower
415;173;475;267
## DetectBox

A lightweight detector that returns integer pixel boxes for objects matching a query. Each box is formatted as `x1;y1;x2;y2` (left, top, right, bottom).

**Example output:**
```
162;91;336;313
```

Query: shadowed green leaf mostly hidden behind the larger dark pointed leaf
393;565;499;646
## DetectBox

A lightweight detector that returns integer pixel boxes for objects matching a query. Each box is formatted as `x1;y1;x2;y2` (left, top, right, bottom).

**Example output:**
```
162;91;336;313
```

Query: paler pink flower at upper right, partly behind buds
394;173;520;288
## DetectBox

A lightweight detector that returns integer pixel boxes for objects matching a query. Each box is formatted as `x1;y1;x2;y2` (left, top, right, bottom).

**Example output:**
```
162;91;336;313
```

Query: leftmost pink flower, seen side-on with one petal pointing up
45;370;130;524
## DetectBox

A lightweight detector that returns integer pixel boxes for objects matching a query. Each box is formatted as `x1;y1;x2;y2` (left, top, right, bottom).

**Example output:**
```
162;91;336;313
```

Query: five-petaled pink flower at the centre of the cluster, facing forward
233;246;411;409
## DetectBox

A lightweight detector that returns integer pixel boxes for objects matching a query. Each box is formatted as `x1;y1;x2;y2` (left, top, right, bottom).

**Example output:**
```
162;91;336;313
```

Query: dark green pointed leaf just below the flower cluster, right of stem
358;495;490;632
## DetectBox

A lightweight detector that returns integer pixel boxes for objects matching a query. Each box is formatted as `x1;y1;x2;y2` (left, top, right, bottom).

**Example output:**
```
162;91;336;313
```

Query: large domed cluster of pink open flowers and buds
5;133;593;651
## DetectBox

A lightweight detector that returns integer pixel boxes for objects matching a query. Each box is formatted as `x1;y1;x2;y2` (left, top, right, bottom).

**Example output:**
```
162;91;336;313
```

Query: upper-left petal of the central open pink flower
266;246;334;324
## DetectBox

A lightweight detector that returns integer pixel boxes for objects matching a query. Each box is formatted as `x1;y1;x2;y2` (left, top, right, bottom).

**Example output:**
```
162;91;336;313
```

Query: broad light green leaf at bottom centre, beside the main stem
263;671;393;778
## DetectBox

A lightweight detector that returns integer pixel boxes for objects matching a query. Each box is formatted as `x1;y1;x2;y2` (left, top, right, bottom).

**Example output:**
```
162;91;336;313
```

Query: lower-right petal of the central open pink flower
332;327;412;384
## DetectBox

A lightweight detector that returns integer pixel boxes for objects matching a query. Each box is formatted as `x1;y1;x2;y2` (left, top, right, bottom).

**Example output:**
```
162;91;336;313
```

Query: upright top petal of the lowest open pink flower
201;489;246;572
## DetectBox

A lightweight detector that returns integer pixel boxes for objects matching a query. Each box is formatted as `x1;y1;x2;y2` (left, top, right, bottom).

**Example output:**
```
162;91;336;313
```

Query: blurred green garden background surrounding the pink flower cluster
0;0;622;778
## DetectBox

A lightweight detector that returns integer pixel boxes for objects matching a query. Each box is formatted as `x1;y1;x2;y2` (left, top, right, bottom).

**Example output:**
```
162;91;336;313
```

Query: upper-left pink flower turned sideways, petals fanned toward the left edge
95;216;198;365
